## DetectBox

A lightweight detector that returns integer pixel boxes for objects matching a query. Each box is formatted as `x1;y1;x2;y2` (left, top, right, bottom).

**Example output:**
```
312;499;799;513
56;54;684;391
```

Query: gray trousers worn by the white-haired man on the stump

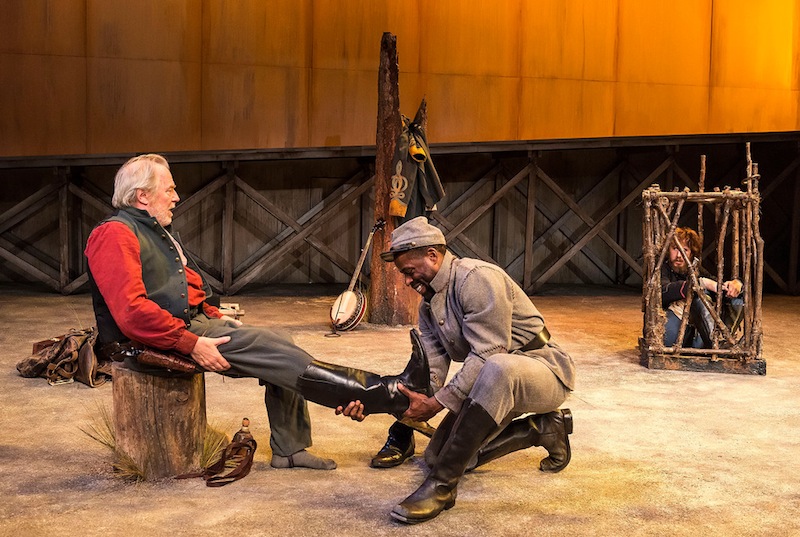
189;313;313;457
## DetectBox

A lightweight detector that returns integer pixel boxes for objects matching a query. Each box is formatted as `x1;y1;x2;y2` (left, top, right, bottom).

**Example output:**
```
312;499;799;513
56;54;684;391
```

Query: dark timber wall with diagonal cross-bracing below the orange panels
0;134;800;294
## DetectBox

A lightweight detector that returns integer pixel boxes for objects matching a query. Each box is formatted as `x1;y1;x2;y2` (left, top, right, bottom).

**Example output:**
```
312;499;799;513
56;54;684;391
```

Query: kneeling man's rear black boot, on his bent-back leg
469;408;572;473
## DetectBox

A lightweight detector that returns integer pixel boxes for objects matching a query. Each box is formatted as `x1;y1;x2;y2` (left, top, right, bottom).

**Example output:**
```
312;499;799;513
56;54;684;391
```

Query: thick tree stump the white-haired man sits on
112;362;207;480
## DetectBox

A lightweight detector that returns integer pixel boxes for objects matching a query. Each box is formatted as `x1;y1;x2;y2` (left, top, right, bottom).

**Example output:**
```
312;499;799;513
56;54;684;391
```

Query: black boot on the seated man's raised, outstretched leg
297;330;431;418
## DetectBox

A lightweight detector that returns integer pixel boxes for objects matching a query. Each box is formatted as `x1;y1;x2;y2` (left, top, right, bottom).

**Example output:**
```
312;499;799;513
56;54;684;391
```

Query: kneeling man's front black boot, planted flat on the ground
391;399;497;524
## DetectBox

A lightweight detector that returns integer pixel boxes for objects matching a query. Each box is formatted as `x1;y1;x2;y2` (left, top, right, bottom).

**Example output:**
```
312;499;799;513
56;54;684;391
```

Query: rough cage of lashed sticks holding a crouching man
639;143;766;375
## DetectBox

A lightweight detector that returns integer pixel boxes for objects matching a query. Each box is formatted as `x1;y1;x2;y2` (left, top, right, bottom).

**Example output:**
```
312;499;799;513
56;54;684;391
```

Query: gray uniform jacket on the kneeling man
419;252;575;412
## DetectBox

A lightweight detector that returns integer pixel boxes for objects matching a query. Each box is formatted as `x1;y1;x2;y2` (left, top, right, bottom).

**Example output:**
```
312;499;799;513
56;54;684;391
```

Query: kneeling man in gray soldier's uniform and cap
343;216;575;524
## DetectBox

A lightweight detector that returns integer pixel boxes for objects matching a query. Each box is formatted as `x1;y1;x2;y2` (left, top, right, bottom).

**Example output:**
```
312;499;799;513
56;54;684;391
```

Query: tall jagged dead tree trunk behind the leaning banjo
367;32;422;325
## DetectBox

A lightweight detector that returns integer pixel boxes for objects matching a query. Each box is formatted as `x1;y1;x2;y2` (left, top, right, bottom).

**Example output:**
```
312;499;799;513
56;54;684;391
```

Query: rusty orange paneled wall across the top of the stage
0;0;800;157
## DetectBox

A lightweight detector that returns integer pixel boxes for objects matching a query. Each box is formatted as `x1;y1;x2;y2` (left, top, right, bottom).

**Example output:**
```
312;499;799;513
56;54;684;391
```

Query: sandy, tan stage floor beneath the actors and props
0;282;800;537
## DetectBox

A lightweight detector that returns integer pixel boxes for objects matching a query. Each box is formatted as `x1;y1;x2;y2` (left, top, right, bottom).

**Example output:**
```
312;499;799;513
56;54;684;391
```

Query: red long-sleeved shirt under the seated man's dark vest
84;222;222;354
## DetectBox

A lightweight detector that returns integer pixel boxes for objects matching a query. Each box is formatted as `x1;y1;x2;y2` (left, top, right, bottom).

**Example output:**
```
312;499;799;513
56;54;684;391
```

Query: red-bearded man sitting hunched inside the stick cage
661;227;744;348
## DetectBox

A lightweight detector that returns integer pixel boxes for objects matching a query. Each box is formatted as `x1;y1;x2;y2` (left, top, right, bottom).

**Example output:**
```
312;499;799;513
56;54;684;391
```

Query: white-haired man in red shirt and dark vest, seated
85;154;429;470
